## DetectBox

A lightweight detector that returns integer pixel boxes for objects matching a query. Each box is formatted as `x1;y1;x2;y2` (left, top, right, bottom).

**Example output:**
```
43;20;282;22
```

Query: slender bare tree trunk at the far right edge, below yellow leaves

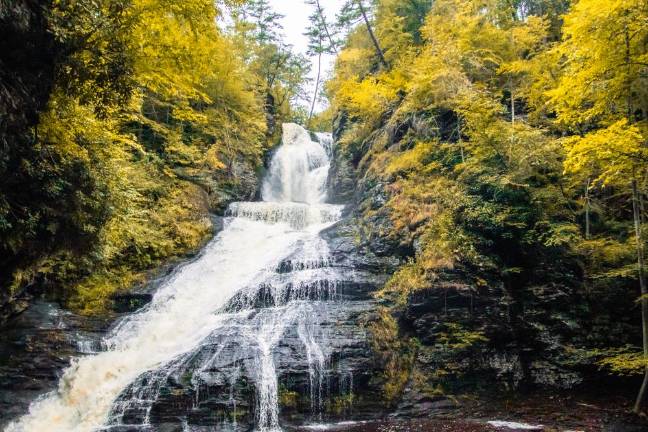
632;180;648;414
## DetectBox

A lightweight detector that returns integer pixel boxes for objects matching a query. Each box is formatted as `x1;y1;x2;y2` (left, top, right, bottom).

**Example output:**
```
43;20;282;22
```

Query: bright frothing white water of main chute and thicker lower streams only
6;124;341;432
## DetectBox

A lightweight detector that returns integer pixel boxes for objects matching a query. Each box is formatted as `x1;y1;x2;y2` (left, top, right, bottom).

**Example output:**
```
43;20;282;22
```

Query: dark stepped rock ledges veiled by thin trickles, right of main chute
101;220;396;431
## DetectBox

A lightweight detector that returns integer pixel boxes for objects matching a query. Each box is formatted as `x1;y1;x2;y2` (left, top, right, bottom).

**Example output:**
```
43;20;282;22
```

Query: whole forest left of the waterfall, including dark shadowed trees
0;0;307;312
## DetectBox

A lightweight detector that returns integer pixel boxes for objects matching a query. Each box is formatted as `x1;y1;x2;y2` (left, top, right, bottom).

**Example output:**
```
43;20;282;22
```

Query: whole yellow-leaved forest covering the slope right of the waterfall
326;0;648;410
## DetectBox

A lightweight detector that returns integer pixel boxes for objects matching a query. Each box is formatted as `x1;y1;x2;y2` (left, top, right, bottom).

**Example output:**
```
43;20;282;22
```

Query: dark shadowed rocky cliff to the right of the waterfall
322;113;640;415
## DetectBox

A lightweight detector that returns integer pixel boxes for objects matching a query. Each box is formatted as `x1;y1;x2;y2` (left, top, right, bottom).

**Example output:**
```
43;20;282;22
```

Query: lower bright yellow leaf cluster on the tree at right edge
563;119;648;186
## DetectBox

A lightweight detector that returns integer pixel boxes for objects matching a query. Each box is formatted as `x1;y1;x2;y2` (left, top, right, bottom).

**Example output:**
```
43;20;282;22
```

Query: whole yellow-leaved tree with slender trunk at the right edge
547;0;648;412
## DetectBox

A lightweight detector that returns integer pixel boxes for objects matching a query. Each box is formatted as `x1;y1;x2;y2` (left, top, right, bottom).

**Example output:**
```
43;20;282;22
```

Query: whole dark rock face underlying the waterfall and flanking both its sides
0;122;644;432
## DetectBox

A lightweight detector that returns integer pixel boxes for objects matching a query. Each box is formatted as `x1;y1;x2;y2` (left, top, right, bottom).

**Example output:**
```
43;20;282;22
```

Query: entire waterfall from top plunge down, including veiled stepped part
6;124;341;432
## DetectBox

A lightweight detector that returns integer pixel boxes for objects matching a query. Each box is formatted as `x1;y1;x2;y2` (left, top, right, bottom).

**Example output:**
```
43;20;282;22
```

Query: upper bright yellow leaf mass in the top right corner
547;0;648;126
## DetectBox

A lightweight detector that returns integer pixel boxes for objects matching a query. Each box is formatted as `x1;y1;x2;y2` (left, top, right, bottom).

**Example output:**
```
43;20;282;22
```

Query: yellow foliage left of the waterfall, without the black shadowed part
14;0;268;313
